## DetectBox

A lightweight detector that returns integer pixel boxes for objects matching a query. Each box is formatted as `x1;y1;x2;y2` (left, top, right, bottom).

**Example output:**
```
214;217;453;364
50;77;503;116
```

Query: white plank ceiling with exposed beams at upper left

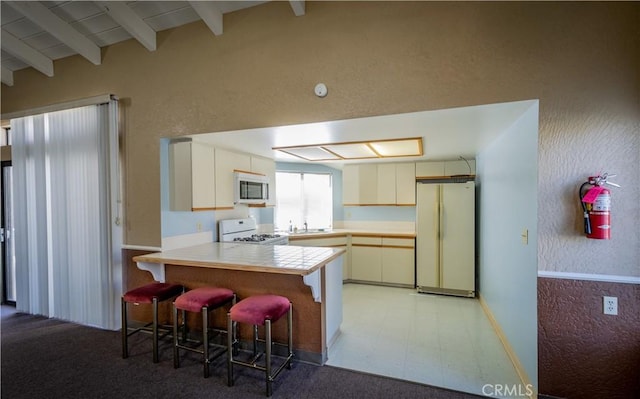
0;0;305;86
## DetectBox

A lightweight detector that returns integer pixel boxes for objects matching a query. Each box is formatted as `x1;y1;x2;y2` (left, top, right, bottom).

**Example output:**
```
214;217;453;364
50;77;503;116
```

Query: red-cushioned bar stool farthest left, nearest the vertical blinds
121;282;184;363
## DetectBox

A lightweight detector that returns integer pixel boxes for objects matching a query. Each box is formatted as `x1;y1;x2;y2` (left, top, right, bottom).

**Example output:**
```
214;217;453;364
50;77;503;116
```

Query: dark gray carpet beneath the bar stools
0;306;478;399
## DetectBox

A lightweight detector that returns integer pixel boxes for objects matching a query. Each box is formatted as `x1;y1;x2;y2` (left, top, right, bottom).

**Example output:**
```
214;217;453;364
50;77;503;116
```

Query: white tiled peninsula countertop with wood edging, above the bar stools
133;242;345;276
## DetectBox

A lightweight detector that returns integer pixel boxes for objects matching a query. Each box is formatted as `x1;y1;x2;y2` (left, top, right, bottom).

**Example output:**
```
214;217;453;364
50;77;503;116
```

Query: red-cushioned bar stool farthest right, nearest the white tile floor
227;295;293;396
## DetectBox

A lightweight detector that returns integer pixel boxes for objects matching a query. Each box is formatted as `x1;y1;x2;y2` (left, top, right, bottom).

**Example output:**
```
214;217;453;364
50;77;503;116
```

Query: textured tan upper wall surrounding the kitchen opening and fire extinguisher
2;2;640;276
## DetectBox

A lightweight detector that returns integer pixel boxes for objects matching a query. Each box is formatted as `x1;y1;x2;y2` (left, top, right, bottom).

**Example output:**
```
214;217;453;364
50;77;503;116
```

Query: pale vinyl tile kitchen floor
327;284;521;395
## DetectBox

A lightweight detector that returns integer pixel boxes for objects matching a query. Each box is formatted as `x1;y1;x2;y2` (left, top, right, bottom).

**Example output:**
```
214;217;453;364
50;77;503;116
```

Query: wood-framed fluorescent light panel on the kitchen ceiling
272;137;423;161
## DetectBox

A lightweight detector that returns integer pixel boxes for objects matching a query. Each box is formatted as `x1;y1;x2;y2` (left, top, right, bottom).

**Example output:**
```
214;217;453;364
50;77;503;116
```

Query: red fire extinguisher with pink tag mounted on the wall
579;173;620;240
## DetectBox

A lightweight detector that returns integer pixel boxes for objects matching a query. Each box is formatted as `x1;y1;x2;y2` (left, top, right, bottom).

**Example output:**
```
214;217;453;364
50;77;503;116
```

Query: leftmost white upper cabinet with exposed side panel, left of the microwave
169;141;216;211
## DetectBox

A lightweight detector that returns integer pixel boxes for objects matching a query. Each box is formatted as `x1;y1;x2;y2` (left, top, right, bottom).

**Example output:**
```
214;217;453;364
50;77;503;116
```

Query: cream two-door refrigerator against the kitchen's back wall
416;181;476;297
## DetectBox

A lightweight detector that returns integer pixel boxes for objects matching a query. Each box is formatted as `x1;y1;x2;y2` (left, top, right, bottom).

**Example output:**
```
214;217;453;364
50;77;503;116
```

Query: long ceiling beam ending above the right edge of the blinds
5;1;102;65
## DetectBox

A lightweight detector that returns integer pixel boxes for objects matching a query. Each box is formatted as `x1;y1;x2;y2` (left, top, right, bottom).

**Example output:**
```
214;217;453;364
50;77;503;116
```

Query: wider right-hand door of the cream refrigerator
441;182;475;291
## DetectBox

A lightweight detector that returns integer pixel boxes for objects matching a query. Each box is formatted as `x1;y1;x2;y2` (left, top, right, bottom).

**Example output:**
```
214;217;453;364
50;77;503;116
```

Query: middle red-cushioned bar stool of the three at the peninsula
173;287;236;378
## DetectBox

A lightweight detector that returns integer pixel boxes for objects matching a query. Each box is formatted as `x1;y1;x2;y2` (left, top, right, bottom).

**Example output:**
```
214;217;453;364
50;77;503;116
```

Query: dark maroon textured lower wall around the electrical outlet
538;278;640;399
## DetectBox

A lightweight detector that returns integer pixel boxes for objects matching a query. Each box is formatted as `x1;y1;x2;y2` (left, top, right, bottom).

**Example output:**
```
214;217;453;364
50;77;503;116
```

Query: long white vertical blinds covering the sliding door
11;100;121;329
